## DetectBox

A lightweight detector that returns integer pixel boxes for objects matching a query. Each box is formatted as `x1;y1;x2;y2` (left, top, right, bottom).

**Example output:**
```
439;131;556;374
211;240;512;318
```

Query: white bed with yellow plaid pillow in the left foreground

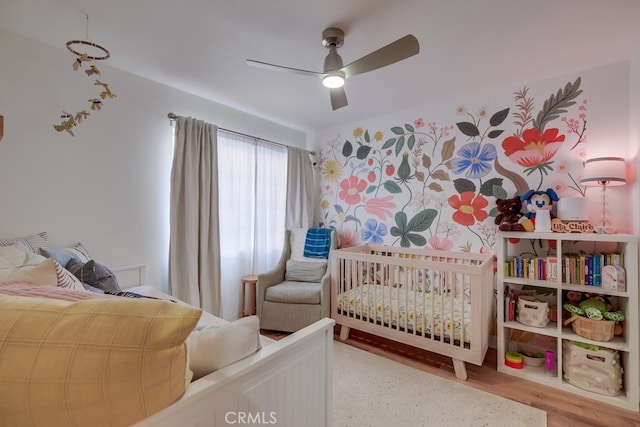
0;233;335;427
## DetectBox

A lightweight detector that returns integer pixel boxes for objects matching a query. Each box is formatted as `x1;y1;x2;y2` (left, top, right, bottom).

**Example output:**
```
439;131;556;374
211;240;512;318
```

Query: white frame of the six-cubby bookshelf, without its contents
497;232;640;412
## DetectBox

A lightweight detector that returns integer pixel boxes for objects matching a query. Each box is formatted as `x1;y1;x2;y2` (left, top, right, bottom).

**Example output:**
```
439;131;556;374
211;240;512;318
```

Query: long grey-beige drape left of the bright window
169;117;220;316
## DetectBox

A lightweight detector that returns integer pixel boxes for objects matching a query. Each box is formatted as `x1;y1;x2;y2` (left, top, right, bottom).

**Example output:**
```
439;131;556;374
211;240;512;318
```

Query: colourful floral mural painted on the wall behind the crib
317;77;587;252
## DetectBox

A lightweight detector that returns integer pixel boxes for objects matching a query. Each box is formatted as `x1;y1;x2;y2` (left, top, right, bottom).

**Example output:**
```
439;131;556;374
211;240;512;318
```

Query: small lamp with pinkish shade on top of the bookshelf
580;157;627;233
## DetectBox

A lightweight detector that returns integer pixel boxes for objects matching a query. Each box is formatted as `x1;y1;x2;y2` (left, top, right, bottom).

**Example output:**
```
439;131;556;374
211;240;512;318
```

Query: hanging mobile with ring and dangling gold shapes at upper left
53;14;116;136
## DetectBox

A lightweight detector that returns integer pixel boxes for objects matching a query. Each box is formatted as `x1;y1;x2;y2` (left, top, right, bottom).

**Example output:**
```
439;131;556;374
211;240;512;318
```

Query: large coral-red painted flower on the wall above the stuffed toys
502;128;564;168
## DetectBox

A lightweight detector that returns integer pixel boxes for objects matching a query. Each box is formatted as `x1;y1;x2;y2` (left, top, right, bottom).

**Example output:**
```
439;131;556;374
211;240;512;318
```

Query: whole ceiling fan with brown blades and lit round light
246;28;420;110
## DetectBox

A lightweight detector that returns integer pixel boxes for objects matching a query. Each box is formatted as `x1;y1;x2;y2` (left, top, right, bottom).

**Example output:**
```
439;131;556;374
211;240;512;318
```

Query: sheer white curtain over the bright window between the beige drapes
218;131;287;320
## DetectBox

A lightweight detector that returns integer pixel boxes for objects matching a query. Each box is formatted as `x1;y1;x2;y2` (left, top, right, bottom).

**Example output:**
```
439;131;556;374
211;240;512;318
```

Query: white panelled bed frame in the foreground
112;265;335;427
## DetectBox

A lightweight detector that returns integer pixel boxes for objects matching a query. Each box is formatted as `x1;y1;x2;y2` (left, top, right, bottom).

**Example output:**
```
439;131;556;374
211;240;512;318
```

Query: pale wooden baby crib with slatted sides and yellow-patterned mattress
330;245;495;380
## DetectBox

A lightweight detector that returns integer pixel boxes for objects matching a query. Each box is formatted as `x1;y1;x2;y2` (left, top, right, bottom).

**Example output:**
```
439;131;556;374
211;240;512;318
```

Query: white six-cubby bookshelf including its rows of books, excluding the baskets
497;232;640;412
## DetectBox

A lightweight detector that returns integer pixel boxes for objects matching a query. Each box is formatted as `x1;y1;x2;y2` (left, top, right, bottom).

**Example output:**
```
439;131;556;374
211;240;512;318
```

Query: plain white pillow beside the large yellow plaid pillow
187;316;260;381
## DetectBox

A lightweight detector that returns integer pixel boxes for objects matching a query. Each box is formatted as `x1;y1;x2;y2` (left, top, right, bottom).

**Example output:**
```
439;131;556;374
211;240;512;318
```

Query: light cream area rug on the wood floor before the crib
333;341;547;427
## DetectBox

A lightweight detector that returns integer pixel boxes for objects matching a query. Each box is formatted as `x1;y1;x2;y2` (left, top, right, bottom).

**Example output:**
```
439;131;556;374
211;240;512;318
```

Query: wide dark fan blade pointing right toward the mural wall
342;34;420;77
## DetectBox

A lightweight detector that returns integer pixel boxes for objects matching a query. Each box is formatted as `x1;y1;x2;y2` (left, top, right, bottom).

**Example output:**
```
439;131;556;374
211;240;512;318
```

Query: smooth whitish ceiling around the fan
0;0;640;131
